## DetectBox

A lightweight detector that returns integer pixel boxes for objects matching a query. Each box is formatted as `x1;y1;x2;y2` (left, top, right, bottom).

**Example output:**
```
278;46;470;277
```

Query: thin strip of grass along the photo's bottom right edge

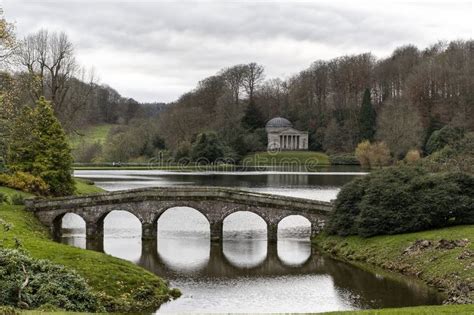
324;304;474;315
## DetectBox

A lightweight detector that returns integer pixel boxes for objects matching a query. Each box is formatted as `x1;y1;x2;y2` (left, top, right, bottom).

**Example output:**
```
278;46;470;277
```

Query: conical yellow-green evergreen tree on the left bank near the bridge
9;97;74;196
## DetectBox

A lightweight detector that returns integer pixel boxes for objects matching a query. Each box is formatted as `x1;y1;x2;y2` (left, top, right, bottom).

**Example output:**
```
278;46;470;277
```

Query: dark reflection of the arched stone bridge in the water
87;239;323;277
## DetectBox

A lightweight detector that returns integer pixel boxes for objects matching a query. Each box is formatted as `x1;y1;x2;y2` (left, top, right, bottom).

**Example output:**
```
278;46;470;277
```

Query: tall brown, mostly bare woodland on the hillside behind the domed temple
159;40;474;162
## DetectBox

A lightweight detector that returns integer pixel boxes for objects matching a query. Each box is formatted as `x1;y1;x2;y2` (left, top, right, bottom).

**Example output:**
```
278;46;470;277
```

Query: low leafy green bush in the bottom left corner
0;249;104;312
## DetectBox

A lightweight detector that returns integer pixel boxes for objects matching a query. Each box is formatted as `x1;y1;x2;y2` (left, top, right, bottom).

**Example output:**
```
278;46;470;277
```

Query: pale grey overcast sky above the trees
2;0;474;102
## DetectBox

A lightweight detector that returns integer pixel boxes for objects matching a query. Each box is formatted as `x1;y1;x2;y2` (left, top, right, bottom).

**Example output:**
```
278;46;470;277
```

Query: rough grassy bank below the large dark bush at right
313;225;474;303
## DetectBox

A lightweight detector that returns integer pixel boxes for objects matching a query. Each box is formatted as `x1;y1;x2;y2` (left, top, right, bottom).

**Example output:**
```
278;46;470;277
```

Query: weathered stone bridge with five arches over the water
25;186;333;242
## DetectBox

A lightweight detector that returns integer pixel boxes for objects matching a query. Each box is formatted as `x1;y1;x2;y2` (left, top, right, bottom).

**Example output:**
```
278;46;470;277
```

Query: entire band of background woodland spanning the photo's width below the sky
0;9;474;165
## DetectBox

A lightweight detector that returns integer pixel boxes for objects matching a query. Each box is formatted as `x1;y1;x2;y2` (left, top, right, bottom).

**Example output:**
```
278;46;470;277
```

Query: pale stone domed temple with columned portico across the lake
265;117;308;150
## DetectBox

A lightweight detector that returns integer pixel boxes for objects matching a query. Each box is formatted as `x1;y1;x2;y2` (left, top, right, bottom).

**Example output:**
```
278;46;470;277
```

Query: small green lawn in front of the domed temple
242;151;330;166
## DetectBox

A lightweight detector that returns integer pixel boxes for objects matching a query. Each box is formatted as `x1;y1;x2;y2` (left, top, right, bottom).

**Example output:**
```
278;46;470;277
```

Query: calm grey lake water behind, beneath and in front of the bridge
58;168;442;313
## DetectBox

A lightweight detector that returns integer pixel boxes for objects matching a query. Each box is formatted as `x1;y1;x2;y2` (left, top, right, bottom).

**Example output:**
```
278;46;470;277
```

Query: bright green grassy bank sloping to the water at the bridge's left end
0;187;176;312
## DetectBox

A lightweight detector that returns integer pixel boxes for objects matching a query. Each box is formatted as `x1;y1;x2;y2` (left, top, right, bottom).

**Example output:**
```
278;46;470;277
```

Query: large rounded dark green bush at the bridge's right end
327;166;474;237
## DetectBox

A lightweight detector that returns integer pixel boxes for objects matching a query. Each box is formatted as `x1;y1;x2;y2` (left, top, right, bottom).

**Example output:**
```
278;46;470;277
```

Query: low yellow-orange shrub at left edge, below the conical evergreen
0;172;49;196
